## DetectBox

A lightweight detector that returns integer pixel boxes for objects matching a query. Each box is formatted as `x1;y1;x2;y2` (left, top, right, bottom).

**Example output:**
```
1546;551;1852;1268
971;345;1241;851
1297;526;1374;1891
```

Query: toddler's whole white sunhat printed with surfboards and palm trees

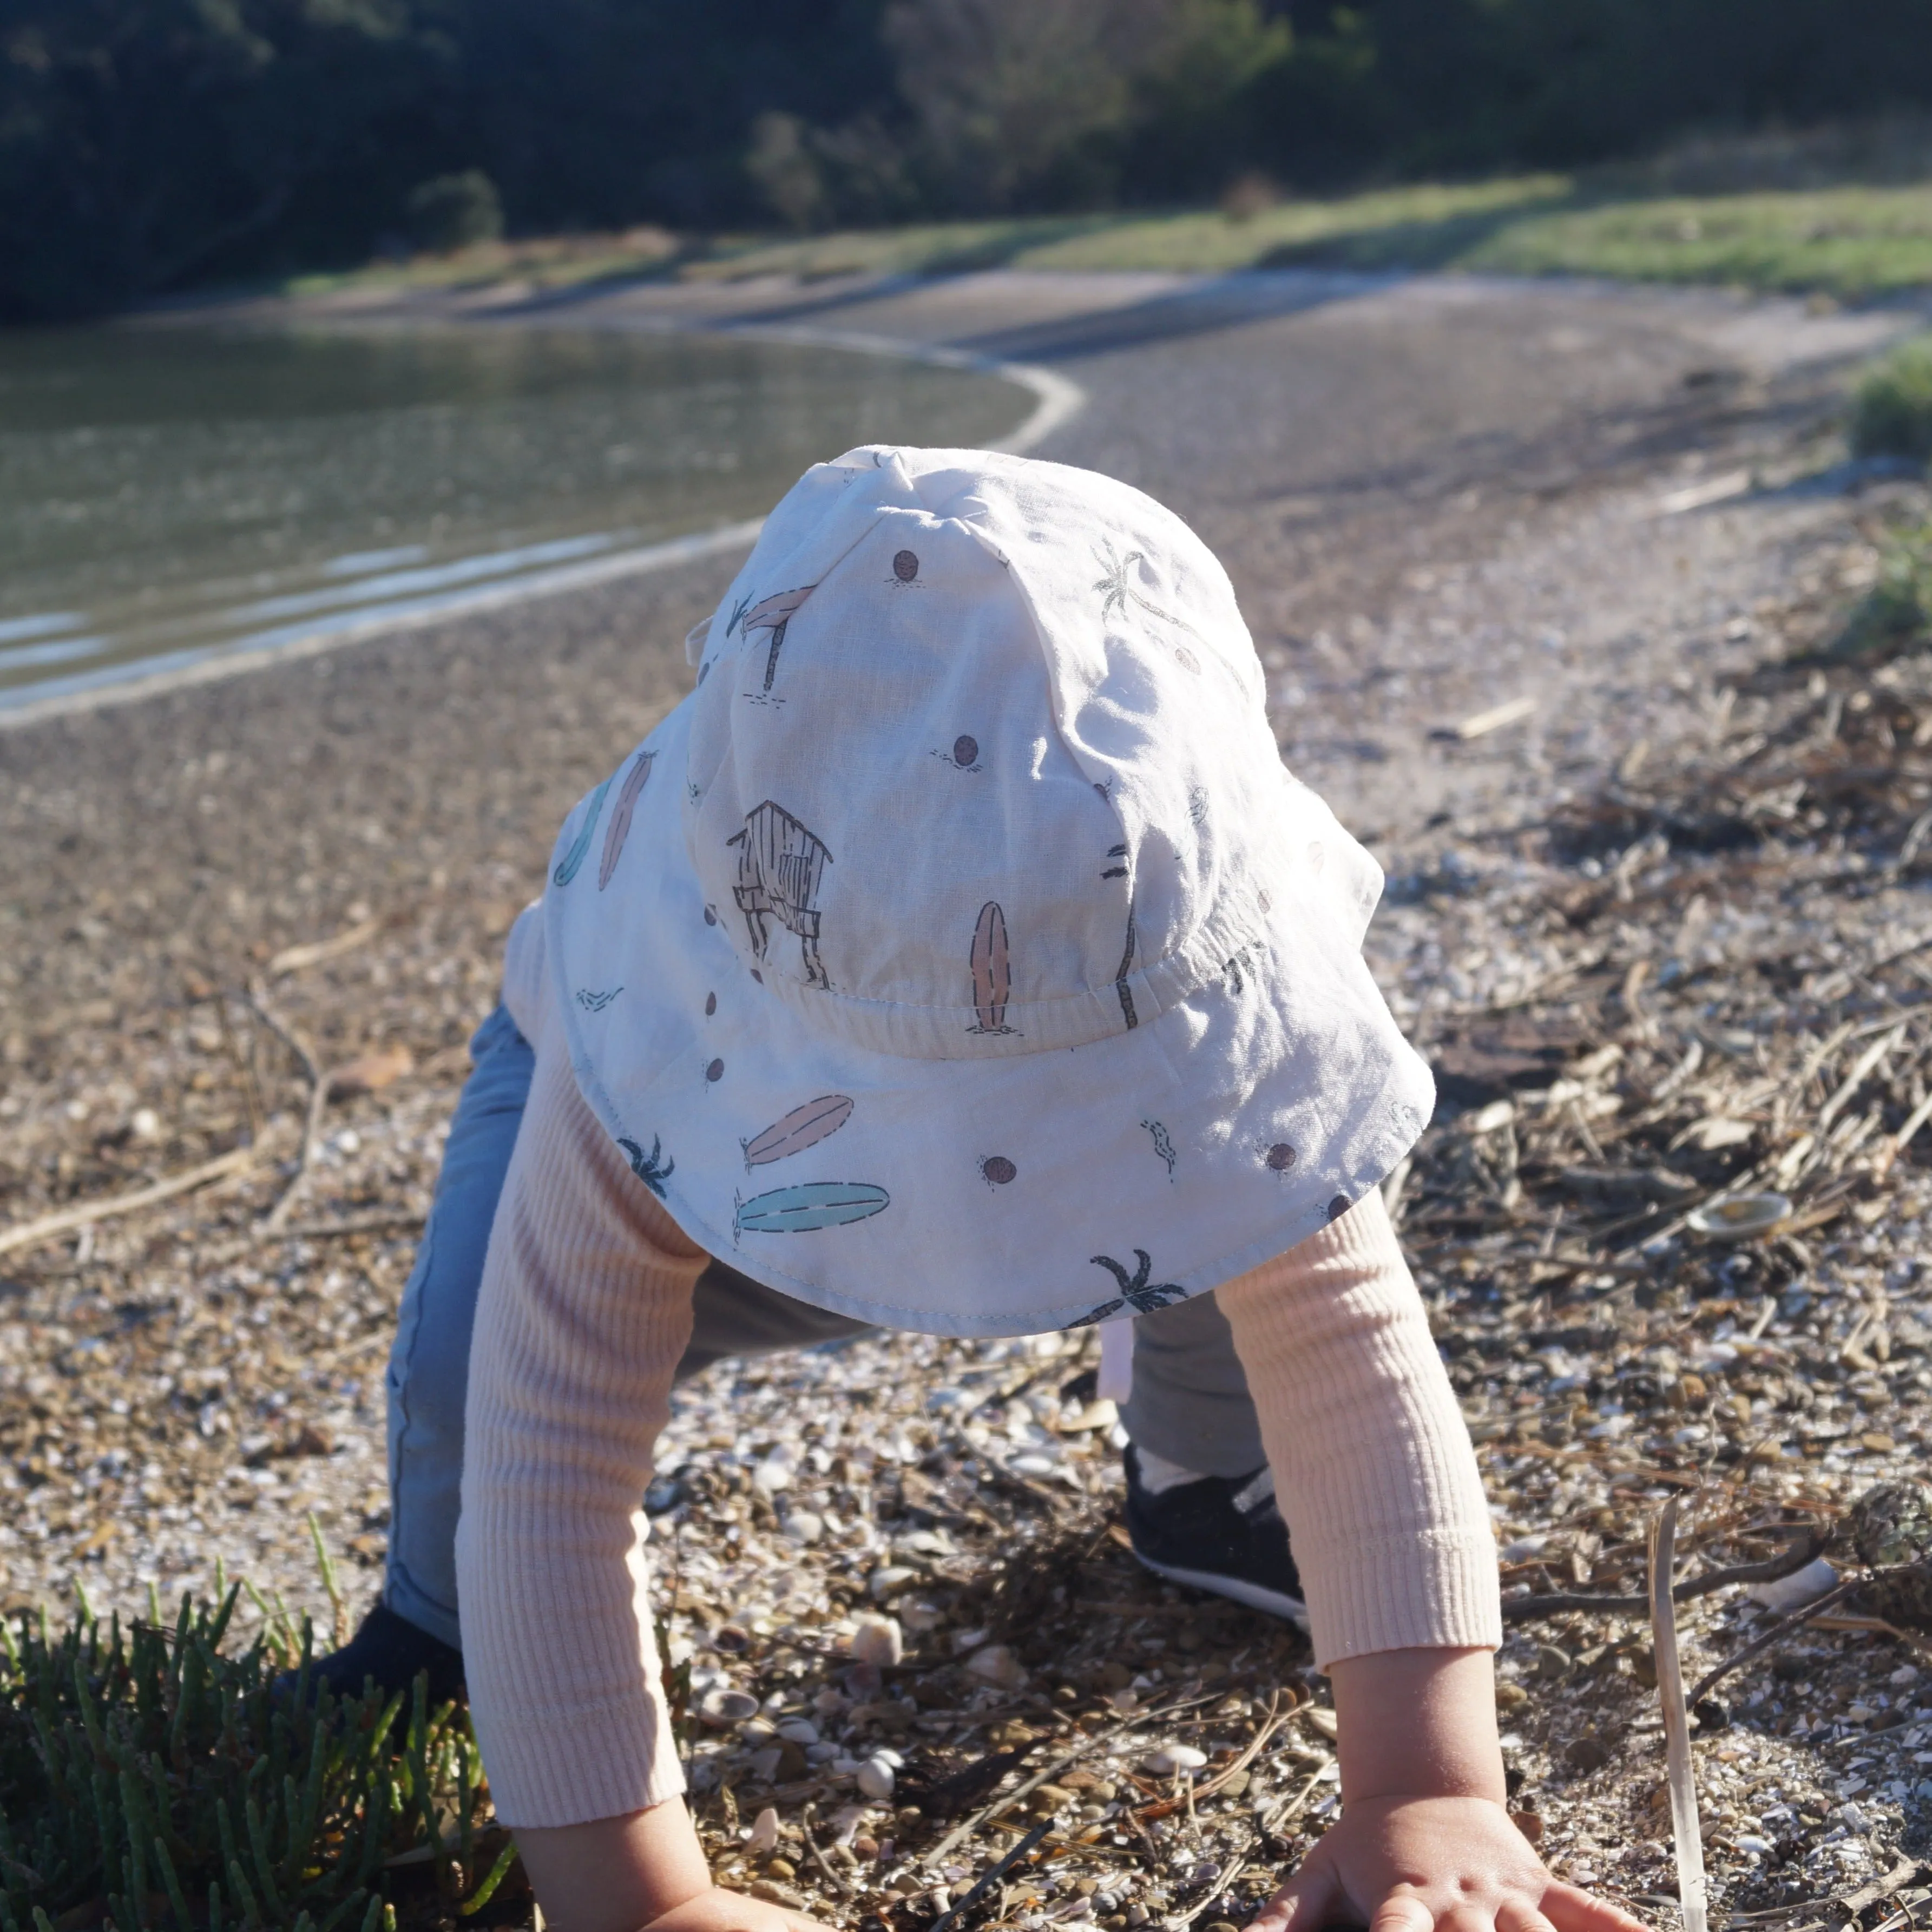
545;448;1434;1335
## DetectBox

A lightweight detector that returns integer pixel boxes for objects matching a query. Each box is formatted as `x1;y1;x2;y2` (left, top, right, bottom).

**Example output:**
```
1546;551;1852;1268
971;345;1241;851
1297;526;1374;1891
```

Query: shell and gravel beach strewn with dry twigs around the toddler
0;277;1932;1928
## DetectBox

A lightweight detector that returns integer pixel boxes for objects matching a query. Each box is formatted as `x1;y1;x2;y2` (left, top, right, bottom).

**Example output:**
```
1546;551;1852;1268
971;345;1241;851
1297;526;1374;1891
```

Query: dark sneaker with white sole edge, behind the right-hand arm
1125;1443;1308;1627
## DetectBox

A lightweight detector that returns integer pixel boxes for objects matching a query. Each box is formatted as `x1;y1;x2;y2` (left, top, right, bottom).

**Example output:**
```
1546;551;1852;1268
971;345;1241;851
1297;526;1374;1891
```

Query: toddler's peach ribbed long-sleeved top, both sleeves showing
456;918;1501;1828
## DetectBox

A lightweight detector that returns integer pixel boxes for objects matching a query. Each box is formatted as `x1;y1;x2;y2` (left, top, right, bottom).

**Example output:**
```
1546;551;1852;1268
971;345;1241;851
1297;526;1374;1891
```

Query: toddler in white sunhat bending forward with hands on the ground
347;448;1634;1932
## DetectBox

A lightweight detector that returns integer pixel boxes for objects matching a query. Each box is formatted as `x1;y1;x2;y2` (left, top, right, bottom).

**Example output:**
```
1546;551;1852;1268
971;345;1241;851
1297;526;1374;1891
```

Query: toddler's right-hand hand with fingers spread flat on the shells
1248;1797;1644;1932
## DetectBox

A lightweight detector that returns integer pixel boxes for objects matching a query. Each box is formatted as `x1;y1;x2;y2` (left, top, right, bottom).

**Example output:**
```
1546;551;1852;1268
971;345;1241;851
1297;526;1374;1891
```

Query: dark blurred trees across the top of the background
0;0;1932;321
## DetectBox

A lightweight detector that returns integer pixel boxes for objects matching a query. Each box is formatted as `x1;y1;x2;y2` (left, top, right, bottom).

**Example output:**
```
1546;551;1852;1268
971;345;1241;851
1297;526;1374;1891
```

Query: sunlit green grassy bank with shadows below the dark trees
288;174;1932;301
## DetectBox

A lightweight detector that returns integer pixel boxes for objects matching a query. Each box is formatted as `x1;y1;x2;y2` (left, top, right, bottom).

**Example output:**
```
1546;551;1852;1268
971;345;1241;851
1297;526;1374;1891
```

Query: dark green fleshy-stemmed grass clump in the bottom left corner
0;1586;516;1932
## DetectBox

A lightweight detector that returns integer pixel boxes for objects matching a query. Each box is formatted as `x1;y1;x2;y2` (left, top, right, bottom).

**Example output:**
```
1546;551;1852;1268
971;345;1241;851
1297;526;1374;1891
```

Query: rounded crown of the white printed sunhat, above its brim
684;448;1292;1059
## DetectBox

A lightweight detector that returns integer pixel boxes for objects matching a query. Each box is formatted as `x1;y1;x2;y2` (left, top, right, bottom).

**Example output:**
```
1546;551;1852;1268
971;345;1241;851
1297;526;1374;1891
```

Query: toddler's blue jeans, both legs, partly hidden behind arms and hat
383;1007;1267;1646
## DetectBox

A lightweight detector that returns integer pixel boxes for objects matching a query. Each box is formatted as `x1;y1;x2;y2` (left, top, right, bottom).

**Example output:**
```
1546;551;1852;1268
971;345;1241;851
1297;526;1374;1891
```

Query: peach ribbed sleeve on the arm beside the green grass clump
456;1028;707;1828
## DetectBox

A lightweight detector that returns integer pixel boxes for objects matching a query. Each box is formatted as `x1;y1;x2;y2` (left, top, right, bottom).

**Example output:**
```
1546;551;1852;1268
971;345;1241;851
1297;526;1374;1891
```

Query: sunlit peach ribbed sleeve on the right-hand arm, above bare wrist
1219;1188;1503;1667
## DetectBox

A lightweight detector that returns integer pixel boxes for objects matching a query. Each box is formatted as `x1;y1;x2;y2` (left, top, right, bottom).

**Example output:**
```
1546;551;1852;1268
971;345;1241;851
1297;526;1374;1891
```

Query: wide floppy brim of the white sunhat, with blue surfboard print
545;701;1434;1335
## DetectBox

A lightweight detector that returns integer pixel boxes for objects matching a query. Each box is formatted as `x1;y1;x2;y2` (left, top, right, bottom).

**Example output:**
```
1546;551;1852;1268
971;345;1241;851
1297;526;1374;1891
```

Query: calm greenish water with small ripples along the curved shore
0;326;1031;709
